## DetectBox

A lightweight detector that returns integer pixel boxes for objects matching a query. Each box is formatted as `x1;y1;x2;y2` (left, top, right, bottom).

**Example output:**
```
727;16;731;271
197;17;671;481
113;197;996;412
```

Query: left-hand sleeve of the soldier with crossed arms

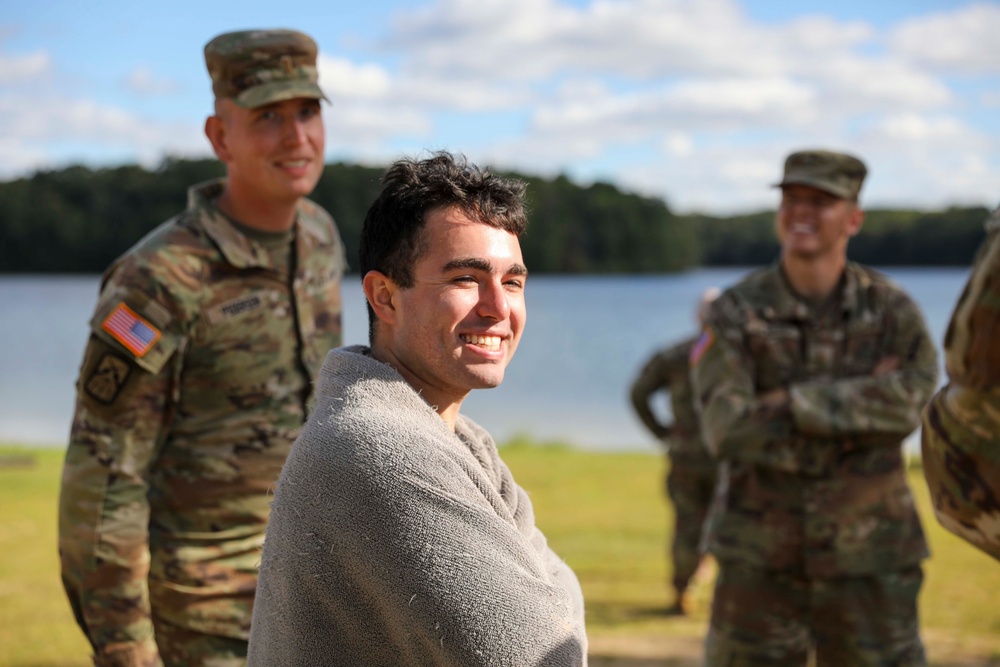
690;297;795;468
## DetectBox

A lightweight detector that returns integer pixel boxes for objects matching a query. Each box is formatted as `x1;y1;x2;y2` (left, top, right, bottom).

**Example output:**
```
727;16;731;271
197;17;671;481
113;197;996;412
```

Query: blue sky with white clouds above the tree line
0;0;1000;214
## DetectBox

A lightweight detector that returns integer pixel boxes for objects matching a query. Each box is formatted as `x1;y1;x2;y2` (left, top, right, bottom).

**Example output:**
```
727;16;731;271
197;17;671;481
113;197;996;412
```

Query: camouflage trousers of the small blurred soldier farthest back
667;454;716;600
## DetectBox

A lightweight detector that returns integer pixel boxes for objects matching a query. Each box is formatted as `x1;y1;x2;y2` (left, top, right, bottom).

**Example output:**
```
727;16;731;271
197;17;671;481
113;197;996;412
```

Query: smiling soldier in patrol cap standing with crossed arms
691;150;937;666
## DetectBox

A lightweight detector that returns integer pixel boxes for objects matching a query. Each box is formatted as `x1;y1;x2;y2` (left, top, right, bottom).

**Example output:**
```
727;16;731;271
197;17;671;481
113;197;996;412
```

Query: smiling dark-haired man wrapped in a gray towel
249;153;586;667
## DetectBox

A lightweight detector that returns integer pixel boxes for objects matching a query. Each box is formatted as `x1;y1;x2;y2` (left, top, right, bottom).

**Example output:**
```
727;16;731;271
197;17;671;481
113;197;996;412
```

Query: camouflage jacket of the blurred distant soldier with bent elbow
632;338;715;468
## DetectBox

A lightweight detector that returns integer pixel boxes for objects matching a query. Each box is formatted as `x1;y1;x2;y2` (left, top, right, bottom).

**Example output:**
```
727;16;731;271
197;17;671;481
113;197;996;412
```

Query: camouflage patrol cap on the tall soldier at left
205;30;326;109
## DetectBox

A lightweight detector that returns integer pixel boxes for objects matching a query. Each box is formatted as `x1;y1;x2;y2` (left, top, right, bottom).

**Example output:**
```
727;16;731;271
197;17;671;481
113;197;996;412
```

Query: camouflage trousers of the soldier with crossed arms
705;563;927;667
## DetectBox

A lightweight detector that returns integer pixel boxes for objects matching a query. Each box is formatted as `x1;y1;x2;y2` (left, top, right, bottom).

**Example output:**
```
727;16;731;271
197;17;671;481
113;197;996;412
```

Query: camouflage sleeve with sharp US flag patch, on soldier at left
59;285;179;666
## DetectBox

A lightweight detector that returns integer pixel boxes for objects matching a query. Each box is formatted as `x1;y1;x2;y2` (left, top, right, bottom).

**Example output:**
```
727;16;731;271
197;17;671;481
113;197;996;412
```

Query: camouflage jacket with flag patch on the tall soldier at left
59;181;345;664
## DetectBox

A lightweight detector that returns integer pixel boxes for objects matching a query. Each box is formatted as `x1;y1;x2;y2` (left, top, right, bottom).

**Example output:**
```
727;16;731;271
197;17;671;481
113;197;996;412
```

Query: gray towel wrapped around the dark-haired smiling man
249;347;587;667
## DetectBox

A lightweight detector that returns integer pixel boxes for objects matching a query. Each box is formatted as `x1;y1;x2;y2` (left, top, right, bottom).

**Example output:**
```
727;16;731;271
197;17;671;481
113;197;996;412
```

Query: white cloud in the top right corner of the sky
889;3;1000;73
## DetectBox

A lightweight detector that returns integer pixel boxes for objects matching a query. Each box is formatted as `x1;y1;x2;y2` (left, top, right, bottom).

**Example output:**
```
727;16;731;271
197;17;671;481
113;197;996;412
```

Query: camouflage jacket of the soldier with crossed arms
692;263;937;577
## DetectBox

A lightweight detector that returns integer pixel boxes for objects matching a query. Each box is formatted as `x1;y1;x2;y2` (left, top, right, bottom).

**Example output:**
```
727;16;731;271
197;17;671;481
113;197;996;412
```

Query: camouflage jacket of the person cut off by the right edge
923;209;1000;559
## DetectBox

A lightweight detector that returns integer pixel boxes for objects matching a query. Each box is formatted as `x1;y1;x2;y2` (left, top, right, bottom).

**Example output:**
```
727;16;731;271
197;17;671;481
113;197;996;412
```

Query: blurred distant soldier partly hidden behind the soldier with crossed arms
631;287;719;616
